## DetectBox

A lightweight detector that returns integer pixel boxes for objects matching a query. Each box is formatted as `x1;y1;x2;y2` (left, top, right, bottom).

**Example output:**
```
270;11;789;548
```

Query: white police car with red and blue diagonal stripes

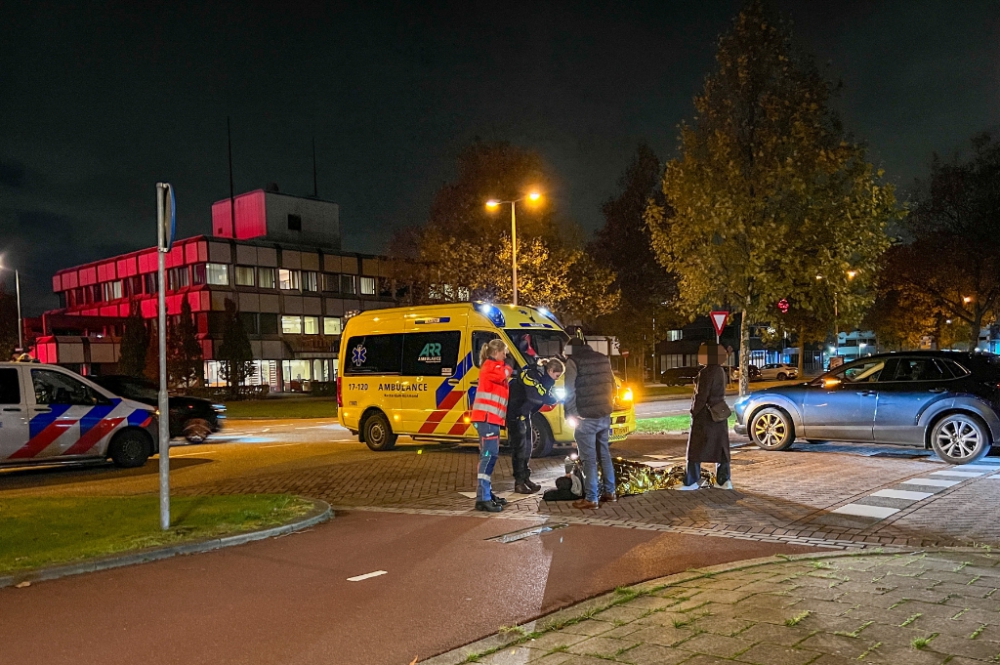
0;363;159;467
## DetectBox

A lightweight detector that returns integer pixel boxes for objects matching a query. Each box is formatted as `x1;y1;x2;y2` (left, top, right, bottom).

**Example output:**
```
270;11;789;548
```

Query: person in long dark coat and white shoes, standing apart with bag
677;344;733;490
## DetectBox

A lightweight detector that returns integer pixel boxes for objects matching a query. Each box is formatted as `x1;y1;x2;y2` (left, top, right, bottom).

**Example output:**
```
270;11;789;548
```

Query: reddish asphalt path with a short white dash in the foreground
0;511;816;665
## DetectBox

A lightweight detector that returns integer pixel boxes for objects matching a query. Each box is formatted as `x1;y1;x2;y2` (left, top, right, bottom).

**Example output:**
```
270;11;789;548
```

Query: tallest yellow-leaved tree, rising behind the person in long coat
646;0;900;394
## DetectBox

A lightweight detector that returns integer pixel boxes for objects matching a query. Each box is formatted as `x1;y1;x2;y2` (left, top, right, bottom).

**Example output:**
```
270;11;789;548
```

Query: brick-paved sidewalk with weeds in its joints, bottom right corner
426;549;1000;665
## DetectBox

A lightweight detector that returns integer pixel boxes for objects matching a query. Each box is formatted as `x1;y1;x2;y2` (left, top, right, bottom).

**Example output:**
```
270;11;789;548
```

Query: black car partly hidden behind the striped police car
87;376;226;443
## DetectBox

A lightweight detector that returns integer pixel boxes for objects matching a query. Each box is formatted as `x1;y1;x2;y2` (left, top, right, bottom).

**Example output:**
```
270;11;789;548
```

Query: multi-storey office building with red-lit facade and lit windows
35;191;395;391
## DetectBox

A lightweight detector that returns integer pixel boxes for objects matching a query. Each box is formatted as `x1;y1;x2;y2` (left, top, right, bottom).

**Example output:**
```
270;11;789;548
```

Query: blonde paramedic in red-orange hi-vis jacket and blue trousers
472;339;512;513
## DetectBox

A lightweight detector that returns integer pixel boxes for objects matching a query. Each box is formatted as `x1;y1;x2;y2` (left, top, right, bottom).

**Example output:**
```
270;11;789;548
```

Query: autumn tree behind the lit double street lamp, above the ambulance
390;141;619;320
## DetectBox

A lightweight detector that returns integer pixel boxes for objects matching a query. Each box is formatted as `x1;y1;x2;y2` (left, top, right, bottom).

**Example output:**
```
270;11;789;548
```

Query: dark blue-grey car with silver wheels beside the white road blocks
735;351;1000;464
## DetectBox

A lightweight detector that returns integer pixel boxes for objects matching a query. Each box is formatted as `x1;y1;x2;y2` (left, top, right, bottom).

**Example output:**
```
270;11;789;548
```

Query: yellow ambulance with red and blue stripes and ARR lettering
337;303;635;457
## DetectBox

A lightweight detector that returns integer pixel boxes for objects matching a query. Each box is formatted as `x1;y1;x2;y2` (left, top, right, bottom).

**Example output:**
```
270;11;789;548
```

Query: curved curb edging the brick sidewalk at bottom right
419;547;982;665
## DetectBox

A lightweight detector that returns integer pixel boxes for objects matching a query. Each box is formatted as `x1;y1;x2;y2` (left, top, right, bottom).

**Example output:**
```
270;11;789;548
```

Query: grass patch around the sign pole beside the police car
0;494;313;573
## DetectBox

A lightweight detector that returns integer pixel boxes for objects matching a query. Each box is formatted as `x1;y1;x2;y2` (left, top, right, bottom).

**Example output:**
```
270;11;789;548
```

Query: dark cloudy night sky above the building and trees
0;0;1000;314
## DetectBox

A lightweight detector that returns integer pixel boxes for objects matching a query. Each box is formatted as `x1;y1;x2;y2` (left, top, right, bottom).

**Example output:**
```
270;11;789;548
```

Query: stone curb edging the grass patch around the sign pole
0;499;334;589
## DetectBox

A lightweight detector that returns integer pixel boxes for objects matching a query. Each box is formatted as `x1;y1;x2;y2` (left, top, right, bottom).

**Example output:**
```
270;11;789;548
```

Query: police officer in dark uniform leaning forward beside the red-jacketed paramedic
507;358;564;494
